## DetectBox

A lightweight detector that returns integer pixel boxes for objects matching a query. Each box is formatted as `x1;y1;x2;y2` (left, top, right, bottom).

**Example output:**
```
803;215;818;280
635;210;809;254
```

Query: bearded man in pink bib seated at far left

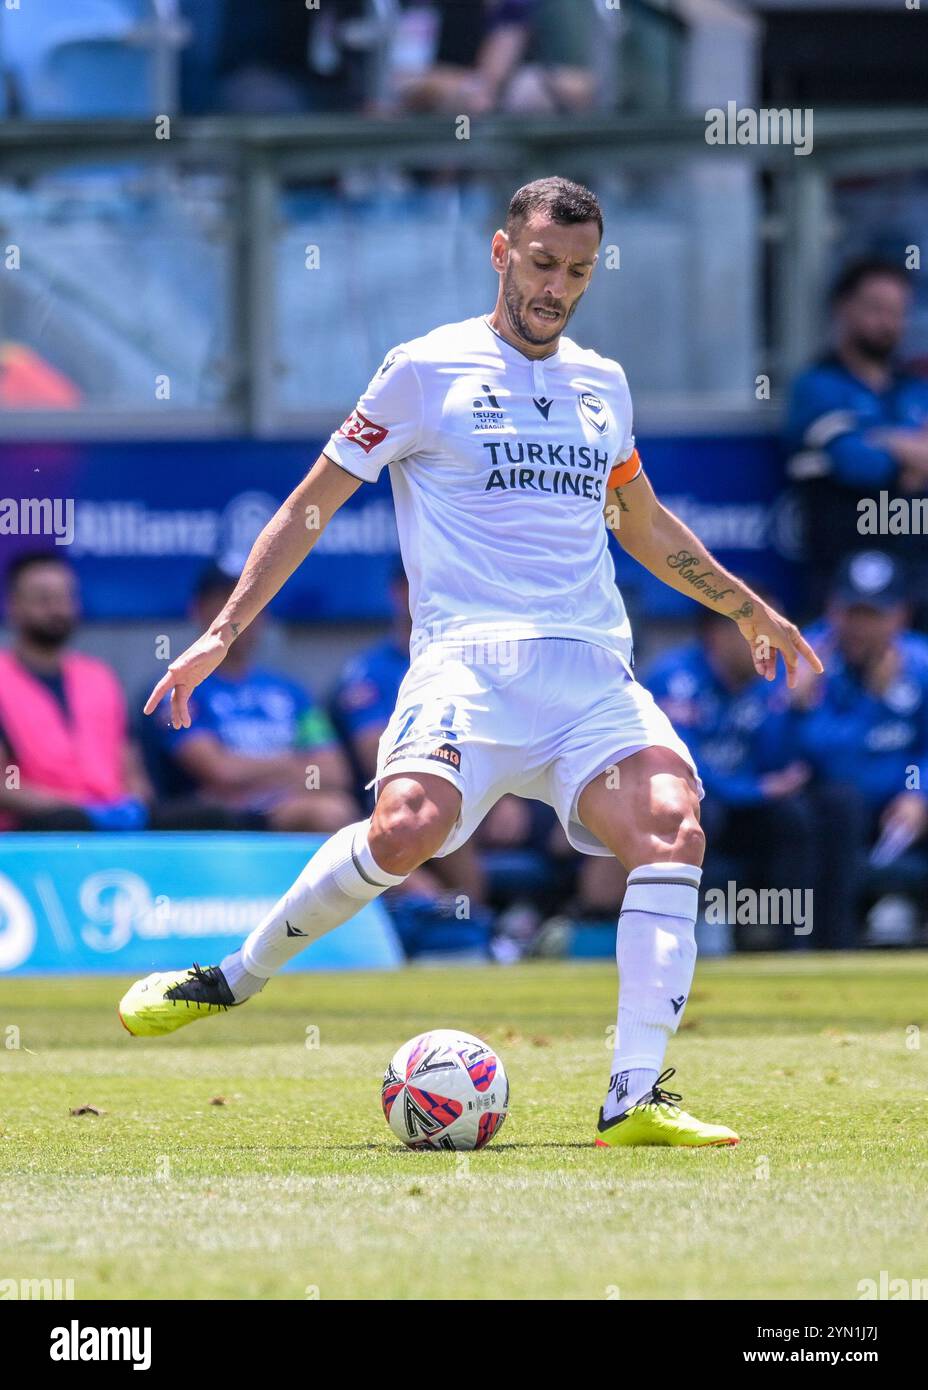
0;552;151;830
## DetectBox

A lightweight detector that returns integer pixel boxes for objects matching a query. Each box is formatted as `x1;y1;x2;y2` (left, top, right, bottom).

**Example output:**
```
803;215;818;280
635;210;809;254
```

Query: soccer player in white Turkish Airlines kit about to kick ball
119;178;821;1147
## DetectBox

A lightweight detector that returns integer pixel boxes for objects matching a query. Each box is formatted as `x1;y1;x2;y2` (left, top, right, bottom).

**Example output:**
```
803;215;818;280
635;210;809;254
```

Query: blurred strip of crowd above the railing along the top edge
1;0;924;118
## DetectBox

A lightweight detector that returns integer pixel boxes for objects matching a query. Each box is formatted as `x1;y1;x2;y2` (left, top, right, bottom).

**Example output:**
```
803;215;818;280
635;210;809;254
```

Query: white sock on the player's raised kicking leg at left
221;819;407;1004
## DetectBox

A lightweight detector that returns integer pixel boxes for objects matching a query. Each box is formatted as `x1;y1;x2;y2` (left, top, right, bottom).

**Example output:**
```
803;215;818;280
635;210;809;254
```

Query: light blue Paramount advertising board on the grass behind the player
0;831;403;976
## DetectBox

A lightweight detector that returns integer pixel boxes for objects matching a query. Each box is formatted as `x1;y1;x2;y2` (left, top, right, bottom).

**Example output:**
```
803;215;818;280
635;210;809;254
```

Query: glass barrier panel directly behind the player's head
274;157;761;416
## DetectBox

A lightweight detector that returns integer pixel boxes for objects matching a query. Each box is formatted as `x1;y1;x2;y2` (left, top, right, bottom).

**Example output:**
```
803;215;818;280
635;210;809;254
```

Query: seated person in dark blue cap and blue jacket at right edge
799;550;928;945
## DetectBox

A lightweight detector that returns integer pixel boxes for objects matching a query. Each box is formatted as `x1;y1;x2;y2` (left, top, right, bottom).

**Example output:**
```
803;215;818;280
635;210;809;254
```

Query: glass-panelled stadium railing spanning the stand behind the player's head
0;111;928;438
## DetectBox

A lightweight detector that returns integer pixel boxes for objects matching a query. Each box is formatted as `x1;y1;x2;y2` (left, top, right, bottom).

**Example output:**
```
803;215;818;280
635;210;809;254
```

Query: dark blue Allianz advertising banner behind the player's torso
0;434;797;623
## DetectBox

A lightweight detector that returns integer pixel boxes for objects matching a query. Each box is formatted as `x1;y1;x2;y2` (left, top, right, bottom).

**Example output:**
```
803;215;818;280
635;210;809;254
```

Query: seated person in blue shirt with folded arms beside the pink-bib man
156;566;358;831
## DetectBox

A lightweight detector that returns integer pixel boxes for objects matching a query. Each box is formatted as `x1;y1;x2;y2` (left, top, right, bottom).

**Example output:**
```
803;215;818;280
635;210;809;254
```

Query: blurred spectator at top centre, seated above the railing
399;0;596;115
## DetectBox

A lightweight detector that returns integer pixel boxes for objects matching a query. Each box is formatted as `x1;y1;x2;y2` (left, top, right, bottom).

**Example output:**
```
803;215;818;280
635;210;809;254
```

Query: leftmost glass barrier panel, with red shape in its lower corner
0;163;238;413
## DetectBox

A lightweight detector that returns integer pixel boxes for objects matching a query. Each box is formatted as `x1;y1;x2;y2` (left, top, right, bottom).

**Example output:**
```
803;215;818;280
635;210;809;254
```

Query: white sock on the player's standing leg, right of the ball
603;863;703;1119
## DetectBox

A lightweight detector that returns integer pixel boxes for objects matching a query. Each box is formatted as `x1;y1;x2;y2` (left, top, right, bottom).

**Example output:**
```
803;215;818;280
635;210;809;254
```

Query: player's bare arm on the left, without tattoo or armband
144;453;361;728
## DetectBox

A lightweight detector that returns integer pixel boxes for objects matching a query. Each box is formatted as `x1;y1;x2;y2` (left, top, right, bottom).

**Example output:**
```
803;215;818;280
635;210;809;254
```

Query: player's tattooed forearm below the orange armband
604;470;824;688
